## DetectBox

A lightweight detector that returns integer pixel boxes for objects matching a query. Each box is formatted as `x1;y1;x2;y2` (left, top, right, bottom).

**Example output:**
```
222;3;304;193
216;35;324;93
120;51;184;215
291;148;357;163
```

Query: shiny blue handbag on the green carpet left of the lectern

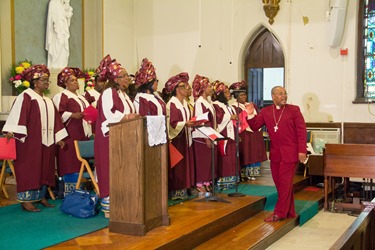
60;189;98;218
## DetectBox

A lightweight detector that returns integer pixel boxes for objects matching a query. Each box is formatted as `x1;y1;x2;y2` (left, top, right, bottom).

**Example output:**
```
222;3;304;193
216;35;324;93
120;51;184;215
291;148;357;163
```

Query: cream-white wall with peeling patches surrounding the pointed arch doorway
101;0;375;122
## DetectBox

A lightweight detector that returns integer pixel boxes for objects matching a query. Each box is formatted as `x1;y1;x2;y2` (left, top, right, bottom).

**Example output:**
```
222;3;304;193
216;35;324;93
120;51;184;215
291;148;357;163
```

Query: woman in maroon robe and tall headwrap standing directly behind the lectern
94;55;137;212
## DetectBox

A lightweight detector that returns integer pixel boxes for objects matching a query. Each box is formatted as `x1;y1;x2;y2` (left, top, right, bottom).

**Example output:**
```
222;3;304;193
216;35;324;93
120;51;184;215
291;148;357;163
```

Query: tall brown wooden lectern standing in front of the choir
109;117;169;236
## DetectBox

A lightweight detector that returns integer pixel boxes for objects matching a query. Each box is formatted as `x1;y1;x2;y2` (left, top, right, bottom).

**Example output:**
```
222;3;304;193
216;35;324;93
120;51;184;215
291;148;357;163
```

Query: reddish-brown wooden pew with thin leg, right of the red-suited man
323;144;375;211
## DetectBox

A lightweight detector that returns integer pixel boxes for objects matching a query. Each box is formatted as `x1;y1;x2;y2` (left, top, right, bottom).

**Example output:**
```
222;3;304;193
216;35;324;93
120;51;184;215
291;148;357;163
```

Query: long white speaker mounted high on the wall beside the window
328;0;348;47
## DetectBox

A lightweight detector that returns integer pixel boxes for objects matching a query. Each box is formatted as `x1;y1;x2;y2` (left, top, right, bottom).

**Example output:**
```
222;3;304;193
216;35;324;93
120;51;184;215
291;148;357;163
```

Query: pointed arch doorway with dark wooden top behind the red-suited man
244;26;285;108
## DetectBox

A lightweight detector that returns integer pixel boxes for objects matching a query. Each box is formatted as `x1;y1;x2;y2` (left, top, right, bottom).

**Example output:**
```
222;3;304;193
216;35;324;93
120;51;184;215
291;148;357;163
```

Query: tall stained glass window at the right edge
363;0;375;99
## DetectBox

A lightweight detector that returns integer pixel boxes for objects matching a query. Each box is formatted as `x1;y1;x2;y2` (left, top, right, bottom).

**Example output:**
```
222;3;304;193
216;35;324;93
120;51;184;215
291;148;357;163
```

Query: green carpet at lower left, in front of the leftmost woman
0;199;109;250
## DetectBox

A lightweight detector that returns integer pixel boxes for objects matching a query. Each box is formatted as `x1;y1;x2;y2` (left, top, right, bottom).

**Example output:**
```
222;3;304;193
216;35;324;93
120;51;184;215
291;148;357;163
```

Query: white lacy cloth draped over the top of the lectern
146;115;167;146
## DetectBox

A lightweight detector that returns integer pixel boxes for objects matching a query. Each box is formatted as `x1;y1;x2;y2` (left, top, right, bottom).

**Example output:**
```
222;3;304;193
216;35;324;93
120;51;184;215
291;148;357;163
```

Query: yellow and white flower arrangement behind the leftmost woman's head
9;59;33;94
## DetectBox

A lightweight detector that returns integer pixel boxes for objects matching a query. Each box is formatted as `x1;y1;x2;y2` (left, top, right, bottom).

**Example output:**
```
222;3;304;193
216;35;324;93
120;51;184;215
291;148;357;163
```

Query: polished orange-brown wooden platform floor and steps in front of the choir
0;164;323;249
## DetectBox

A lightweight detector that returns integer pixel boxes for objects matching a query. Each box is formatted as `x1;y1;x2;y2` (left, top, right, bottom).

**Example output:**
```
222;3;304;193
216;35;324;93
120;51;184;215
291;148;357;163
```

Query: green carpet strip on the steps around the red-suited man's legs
222;184;319;226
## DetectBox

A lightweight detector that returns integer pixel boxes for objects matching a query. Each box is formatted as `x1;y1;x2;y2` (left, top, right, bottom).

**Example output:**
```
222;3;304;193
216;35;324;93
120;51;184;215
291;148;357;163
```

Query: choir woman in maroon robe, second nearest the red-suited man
212;81;237;190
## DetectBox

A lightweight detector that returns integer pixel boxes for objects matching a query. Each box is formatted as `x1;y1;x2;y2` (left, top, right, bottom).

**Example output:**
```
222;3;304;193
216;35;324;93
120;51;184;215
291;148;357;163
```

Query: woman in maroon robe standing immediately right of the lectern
163;72;195;200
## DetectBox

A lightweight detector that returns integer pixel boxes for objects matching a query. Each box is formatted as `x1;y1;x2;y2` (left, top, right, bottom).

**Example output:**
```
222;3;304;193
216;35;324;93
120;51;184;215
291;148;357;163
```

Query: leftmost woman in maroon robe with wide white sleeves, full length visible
3;65;68;212
